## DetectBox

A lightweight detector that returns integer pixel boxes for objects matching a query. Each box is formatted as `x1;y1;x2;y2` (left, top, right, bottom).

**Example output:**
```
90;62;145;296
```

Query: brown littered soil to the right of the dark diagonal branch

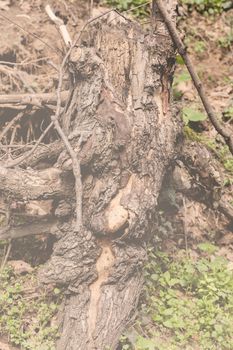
177;10;233;114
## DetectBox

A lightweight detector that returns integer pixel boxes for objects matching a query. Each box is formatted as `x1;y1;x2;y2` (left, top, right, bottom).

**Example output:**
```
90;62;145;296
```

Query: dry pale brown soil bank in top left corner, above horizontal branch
0;0;88;94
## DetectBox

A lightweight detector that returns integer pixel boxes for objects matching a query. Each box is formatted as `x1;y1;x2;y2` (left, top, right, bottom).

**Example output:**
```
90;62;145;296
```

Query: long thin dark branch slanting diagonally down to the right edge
154;0;233;154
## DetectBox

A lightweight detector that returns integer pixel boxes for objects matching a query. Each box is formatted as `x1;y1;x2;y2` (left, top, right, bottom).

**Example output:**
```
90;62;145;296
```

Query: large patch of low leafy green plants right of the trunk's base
121;246;233;350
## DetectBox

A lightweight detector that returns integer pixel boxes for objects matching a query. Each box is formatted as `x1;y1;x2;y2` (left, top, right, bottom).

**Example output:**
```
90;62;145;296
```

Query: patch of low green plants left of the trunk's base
0;267;59;350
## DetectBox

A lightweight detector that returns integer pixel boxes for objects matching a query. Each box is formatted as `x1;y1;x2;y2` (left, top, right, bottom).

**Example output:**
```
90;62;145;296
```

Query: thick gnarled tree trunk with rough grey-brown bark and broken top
0;1;179;350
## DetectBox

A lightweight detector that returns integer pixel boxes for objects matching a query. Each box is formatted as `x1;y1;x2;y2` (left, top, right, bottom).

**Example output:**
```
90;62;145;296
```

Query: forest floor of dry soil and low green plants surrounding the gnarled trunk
0;0;233;350
